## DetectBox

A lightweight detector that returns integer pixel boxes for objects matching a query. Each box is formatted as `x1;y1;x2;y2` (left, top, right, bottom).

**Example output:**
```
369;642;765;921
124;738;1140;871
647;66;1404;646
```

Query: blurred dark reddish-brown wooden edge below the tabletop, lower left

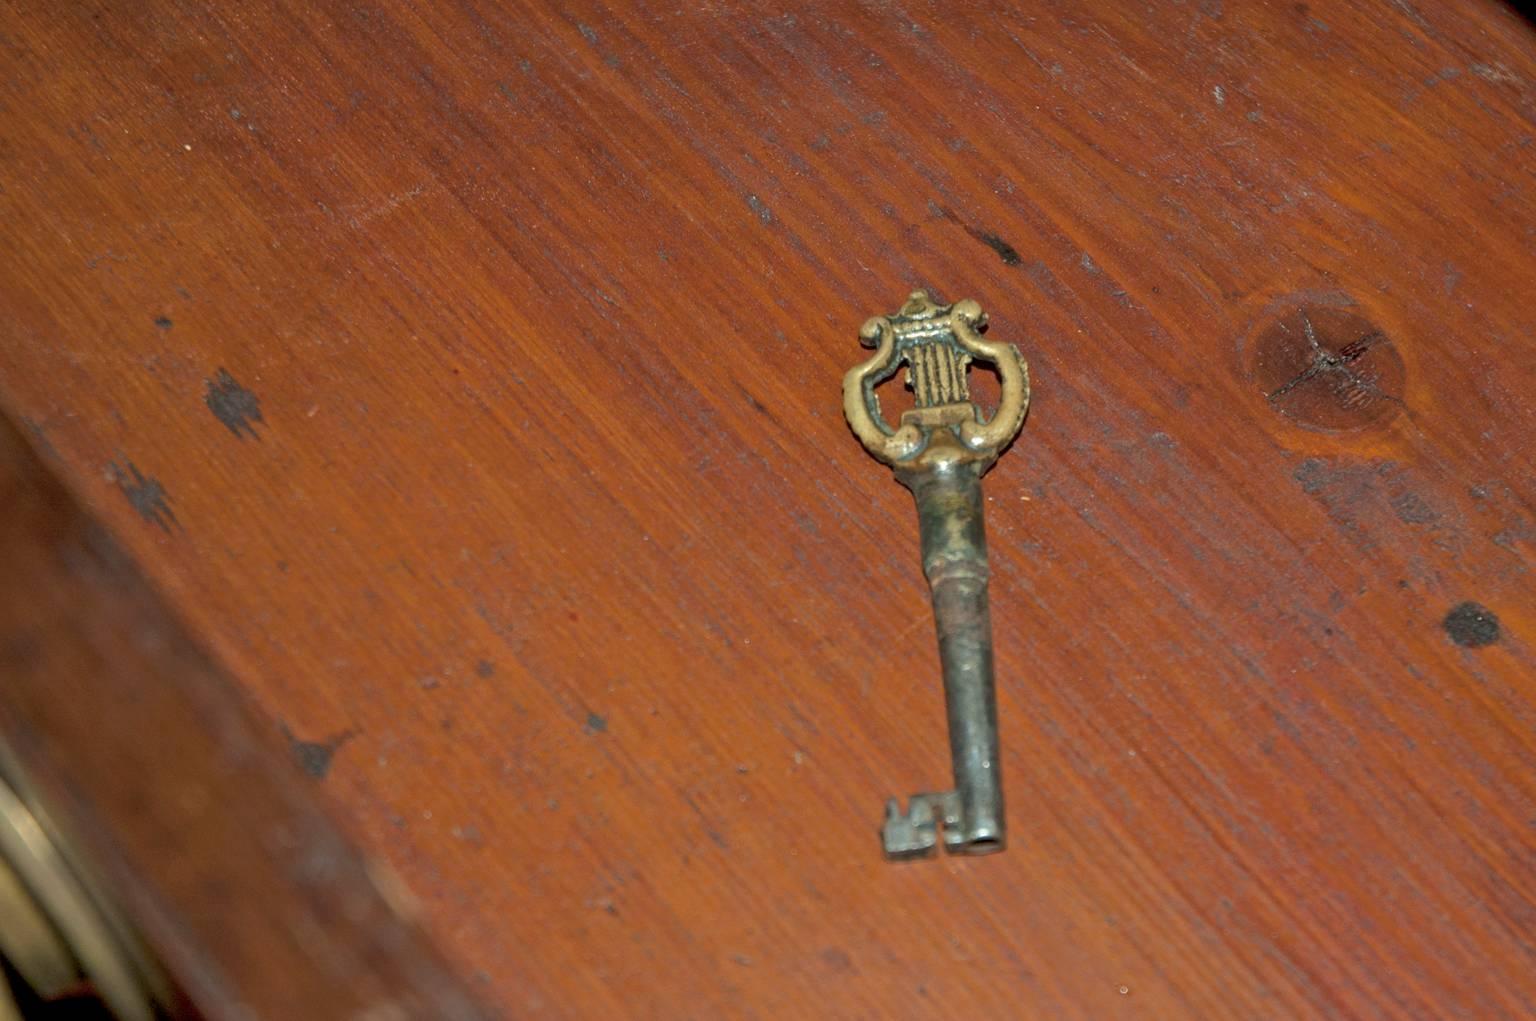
0;421;487;1021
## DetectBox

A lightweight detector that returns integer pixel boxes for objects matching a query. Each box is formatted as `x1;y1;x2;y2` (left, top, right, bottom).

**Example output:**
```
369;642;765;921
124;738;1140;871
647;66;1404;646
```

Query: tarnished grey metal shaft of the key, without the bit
897;464;1005;854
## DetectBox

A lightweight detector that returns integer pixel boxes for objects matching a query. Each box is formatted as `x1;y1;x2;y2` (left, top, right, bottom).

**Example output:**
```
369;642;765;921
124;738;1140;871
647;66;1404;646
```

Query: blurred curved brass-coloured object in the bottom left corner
0;746;169;1021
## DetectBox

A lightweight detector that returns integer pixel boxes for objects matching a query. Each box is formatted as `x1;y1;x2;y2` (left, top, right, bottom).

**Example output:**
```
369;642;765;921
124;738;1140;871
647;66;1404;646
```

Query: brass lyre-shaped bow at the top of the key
843;290;1029;468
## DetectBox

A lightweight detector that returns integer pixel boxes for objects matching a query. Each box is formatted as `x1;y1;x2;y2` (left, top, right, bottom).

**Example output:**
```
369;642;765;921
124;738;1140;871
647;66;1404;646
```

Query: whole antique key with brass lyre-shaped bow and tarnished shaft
843;290;1029;858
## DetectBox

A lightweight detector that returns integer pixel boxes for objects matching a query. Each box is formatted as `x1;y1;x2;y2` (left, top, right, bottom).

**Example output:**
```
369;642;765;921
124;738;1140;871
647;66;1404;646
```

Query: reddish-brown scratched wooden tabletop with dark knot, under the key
0;0;1536;1019
